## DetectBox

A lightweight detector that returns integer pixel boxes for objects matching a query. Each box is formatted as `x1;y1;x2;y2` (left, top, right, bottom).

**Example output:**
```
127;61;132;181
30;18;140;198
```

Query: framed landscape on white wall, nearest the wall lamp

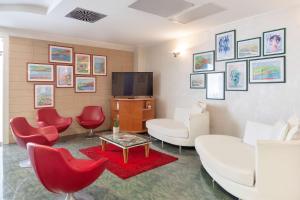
193;51;215;72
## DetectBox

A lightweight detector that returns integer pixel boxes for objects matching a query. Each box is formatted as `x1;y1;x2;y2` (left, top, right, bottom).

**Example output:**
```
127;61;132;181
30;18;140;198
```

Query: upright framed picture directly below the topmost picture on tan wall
56;65;74;88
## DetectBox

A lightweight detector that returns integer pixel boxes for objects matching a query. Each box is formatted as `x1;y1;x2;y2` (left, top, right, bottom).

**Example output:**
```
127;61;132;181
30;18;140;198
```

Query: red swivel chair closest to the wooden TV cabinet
76;106;105;137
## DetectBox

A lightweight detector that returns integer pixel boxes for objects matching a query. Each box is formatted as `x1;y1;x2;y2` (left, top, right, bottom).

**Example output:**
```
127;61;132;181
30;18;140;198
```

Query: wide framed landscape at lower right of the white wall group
249;56;285;83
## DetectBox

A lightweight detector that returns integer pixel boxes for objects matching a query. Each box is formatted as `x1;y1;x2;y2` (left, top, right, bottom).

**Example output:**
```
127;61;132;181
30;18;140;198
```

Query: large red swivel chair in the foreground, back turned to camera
27;143;107;199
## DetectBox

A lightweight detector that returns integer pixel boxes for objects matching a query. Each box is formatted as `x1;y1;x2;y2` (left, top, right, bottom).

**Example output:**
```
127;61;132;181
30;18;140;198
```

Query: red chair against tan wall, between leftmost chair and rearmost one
37;108;72;133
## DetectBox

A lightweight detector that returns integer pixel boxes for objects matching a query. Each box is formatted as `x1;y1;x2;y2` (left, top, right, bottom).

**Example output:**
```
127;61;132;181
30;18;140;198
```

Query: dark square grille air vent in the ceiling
66;8;106;23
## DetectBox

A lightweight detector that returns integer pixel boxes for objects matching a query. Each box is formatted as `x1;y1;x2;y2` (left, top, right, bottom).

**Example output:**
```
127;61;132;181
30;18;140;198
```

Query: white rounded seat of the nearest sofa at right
195;135;255;186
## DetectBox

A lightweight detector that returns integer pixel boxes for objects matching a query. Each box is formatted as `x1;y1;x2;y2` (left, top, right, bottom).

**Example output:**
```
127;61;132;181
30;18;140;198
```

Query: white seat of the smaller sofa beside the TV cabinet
146;119;189;138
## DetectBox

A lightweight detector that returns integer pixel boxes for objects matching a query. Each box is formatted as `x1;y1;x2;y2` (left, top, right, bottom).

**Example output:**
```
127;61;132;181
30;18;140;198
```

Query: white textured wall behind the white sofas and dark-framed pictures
144;7;300;136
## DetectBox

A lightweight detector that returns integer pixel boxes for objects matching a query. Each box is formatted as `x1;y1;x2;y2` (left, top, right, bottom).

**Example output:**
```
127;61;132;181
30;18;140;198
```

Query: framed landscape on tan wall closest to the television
75;77;96;92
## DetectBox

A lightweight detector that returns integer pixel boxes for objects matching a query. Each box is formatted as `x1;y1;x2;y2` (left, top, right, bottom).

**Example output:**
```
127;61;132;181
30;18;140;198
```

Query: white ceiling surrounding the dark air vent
0;0;299;46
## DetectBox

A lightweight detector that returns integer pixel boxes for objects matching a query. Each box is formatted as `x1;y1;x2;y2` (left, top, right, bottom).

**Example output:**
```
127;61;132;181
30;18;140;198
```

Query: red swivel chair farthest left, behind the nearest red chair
10;117;58;167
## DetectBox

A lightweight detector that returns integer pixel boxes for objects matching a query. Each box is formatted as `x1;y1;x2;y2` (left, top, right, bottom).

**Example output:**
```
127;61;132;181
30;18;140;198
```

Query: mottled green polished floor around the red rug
3;136;235;200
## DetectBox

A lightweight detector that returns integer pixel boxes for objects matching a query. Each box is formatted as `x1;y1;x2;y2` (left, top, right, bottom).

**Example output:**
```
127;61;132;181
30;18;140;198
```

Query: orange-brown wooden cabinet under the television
111;98;155;133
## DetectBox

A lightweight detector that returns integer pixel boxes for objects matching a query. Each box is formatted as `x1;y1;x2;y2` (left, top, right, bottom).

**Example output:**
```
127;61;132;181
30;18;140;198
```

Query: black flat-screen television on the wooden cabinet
112;72;153;97
